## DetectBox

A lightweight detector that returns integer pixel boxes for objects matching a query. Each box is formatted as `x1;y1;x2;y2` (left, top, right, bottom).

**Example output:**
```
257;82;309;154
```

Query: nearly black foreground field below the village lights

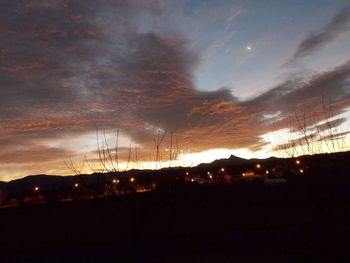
0;176;350;262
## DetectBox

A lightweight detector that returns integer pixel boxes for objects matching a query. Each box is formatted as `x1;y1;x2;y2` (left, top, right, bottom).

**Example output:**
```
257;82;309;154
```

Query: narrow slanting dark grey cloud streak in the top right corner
284;5;350;66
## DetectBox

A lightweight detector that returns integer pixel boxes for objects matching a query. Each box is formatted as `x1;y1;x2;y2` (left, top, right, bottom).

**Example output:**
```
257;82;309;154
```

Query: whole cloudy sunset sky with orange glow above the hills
0;0;350;181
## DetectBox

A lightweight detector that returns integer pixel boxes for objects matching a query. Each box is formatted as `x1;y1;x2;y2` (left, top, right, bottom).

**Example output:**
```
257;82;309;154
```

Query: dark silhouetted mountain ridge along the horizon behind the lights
0;152;350;196
